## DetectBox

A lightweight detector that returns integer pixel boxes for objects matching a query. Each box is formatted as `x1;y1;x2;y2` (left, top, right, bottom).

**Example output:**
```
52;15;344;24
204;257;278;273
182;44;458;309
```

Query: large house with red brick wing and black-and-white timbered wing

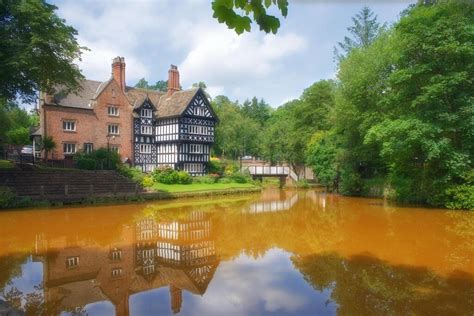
39;57;217;175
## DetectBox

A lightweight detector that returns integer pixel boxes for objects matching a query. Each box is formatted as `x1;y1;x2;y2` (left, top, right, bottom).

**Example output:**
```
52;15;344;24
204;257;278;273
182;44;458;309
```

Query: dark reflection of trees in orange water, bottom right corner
292;254;474;315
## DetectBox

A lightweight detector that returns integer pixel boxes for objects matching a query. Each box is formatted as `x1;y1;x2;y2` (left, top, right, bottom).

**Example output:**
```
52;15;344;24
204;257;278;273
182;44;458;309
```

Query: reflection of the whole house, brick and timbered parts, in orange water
36;212;218;315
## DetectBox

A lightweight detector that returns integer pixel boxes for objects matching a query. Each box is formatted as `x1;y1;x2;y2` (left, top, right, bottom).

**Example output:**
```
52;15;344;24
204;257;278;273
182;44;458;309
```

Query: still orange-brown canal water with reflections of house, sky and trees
0;189;474;315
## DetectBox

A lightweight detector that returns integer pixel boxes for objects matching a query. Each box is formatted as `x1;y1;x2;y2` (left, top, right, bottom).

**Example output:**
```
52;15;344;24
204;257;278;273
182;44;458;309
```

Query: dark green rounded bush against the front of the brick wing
74;148;122;170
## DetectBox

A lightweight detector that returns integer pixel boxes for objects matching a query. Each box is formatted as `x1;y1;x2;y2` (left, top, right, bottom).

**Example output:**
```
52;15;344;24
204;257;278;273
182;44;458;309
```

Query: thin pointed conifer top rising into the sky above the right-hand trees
334;7;386;60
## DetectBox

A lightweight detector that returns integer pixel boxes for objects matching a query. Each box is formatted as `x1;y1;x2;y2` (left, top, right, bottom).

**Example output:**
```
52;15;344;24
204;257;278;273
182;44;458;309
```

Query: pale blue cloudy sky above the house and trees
53;0;414;107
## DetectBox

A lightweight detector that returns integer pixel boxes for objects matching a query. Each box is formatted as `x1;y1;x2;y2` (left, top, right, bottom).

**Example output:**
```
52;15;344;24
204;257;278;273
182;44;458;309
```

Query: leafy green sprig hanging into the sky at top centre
212;0;288;34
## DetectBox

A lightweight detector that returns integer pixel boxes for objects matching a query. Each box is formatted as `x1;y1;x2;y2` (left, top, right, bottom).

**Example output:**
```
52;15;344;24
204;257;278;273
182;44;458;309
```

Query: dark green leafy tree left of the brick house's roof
0;0;85;102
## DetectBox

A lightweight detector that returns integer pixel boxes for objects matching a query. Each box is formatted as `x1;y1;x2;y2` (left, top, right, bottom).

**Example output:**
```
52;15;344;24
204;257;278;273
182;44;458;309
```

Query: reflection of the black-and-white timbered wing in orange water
135;212;217;312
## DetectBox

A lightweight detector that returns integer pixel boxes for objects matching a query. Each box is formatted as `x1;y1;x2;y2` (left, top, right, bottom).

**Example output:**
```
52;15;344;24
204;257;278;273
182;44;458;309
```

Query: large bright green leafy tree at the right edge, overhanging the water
365;1;474;205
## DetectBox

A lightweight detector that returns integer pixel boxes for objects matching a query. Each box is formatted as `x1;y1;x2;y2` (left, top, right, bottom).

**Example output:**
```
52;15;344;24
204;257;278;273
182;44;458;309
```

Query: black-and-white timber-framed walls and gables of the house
133;89;217;176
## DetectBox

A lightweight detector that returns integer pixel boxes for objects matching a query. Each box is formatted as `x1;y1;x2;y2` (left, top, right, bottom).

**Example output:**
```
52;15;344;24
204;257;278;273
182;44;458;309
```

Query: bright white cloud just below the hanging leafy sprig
180;27;306;87
